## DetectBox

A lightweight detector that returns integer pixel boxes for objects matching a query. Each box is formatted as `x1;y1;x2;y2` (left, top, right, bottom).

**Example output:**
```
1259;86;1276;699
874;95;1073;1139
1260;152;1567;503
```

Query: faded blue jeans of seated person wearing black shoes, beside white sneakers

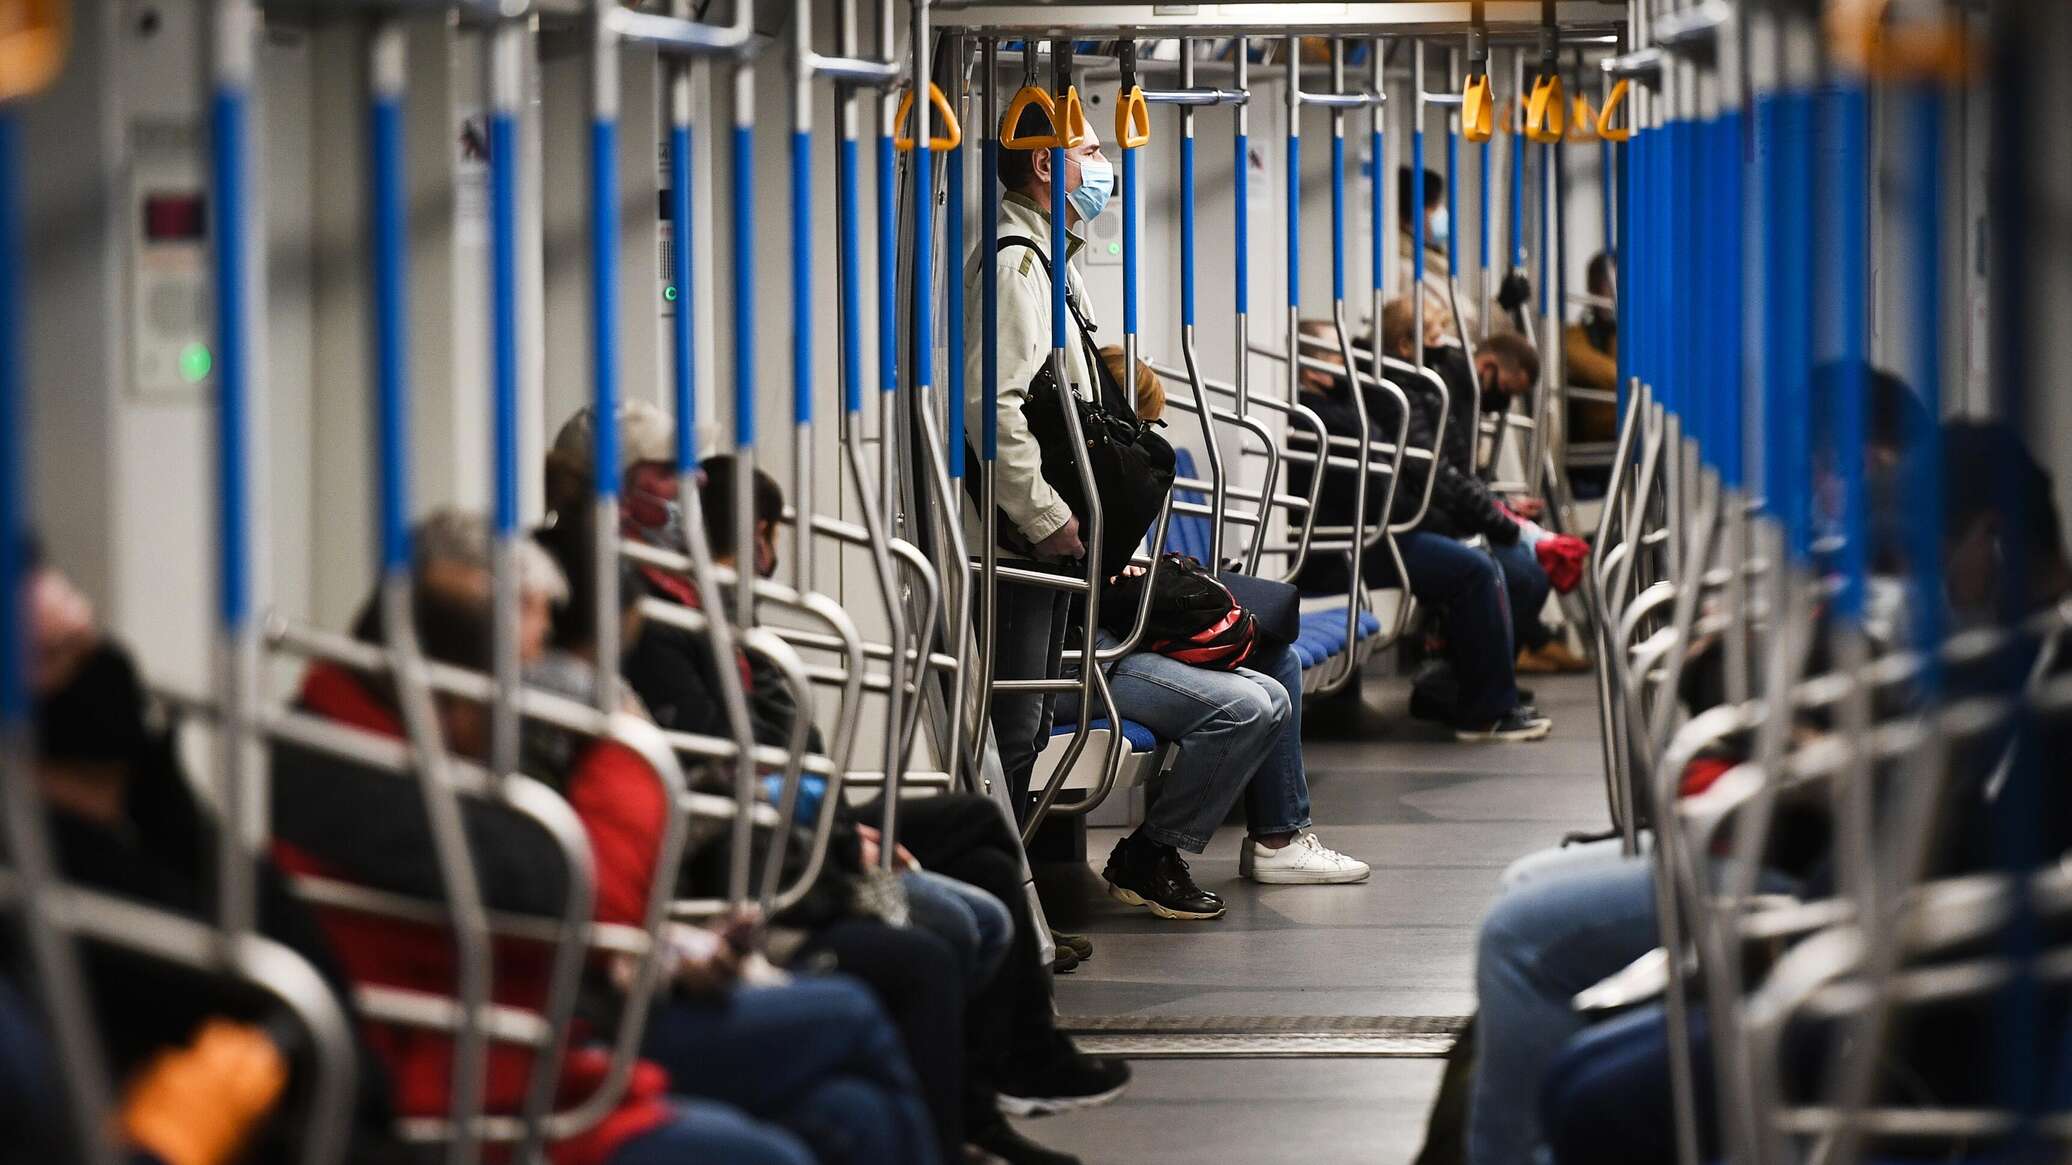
1059;632;1301;854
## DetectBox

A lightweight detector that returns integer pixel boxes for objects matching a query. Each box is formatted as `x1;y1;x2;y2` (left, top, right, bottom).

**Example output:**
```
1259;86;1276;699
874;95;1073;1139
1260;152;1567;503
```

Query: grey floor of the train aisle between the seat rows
1024;661;1606;1165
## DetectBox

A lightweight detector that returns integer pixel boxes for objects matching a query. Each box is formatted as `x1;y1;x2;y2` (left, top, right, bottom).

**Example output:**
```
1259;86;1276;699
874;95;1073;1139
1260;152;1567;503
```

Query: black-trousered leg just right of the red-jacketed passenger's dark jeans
798;918;966;1159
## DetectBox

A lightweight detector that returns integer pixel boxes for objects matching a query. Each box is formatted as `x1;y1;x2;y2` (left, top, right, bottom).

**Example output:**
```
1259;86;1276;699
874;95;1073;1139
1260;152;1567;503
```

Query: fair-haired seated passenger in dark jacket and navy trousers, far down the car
1291;310;1554;742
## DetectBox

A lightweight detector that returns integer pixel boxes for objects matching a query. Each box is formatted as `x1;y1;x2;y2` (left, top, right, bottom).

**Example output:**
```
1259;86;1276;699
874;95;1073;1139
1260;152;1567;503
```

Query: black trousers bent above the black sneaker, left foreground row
860;794;1059;1128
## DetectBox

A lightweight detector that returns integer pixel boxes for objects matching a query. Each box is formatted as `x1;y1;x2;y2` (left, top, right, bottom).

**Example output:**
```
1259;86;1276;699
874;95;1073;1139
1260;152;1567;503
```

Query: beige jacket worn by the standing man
963;193;1096;549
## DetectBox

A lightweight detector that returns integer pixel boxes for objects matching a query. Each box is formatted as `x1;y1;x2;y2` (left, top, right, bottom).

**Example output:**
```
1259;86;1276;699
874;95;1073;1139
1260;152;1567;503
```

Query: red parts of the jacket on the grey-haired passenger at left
274;663;669;1165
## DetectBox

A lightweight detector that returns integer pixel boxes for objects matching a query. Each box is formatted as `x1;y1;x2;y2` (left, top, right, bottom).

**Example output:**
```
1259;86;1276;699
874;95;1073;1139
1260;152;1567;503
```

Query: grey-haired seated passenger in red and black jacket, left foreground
271;512;814;1165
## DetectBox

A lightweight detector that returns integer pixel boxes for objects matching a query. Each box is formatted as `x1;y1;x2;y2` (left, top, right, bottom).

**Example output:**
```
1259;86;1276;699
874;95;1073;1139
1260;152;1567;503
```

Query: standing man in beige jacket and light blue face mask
963;97;1115;815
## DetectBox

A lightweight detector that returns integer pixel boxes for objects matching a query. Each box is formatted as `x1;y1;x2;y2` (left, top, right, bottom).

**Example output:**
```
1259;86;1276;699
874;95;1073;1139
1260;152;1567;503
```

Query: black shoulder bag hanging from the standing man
963;238;1175;574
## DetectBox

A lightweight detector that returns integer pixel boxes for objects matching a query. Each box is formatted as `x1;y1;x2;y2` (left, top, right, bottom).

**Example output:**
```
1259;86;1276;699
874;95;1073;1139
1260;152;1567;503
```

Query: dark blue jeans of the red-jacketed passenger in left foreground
642;976;937;1165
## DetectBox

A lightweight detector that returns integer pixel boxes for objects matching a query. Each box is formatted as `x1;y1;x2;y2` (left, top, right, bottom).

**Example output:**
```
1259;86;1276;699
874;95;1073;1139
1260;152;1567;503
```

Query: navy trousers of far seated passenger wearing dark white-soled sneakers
1365;531;1519;728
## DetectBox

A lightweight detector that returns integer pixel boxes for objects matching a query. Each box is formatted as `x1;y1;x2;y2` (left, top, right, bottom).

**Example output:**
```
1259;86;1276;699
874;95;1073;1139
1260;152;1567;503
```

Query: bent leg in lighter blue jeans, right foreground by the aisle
1467;858;1656;1165
